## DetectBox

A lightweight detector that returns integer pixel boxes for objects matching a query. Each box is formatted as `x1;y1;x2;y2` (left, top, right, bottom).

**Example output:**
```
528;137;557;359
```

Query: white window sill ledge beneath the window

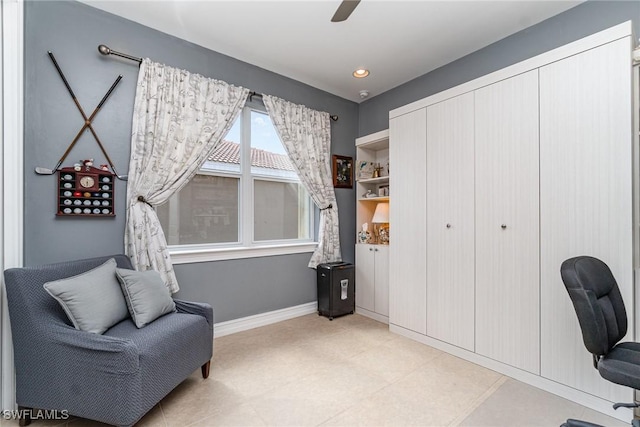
169;242;318;264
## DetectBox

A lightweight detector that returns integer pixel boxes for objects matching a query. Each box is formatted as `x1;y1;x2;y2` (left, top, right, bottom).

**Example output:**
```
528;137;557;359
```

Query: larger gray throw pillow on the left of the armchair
44;258;129;334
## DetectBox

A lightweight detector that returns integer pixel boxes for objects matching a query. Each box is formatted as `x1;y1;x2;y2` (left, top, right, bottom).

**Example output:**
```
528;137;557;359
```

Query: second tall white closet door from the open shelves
427;92;475;351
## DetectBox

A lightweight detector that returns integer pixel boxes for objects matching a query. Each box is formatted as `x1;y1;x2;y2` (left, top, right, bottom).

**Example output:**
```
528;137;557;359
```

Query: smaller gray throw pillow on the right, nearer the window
116;268;176;328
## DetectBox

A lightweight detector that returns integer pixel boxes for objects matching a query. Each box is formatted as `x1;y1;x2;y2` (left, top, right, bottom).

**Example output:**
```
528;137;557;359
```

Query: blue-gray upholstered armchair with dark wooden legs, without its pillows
5;255;213;426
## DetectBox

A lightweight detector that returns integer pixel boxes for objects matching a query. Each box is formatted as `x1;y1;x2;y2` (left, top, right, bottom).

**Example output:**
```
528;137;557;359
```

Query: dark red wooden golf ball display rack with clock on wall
56;166;115;218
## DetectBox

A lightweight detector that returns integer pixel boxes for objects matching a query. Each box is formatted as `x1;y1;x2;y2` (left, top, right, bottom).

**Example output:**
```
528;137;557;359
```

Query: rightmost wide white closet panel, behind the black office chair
540;37;633;401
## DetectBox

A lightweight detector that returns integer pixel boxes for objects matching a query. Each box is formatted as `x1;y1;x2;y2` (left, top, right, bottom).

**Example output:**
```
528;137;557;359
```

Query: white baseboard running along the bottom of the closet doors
389;324;633;422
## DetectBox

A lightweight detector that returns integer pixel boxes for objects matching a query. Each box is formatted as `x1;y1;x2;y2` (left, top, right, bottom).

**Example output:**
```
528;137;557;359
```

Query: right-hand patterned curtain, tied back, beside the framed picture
262;95;342;268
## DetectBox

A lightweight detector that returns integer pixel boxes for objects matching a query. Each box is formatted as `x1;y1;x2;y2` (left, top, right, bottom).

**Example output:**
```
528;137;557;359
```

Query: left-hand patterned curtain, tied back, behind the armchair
125;59;249;293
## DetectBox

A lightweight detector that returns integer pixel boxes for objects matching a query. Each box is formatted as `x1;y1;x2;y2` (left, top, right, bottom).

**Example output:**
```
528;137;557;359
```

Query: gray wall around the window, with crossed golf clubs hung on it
24;1;358;322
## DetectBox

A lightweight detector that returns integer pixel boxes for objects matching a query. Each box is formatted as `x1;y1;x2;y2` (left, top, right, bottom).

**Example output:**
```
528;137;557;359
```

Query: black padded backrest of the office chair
560;256;627;356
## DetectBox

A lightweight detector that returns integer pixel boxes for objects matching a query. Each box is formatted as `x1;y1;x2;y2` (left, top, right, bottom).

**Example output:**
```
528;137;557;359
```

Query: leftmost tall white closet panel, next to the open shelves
389;108;427;334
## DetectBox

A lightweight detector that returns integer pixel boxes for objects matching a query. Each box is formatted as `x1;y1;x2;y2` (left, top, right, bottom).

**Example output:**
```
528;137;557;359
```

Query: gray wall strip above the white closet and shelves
358;1;640;136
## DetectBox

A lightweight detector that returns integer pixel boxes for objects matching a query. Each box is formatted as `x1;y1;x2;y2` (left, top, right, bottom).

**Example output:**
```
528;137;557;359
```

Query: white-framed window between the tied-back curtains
157;107;313;260
